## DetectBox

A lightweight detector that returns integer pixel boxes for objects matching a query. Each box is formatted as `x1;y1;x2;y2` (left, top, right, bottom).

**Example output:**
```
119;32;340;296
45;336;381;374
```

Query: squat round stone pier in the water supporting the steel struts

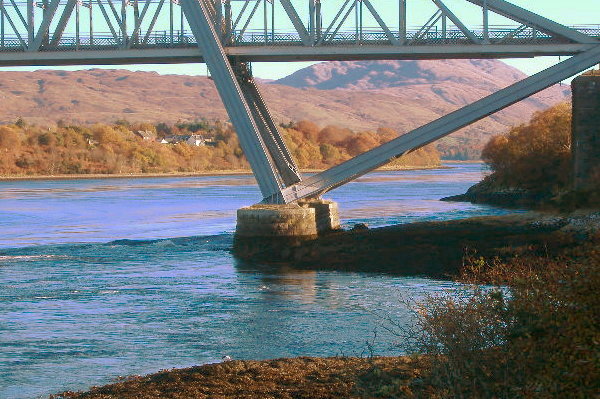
234;199;340;261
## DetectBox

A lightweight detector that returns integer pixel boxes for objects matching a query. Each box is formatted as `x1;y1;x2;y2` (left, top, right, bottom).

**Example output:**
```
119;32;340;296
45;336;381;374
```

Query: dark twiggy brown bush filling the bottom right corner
418;244;600;399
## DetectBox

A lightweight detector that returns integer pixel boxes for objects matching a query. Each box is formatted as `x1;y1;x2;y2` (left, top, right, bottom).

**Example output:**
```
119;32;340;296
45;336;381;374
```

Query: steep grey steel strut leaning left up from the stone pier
181;0;302;203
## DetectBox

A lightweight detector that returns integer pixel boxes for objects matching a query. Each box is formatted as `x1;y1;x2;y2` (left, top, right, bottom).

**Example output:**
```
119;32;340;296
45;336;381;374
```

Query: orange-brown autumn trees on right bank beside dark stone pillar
449;103;600;209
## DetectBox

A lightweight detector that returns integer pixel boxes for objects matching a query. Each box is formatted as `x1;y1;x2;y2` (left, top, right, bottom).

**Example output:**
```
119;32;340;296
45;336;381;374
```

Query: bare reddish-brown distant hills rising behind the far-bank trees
0;60;570;157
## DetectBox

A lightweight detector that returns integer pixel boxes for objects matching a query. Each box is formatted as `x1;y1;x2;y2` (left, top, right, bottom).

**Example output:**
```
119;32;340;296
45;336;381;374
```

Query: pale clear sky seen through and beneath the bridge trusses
0;0;600;79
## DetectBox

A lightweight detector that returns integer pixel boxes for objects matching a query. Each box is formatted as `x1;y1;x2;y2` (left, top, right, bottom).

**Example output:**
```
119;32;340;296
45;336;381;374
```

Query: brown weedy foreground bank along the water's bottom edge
52;357;420;399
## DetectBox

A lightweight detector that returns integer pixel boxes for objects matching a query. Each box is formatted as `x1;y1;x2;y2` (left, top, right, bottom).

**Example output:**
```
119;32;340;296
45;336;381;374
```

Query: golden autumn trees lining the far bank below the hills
0;120;440;176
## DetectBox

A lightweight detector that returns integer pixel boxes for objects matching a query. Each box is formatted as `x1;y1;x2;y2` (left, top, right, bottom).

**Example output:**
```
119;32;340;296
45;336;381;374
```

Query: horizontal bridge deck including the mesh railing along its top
0;25;600;66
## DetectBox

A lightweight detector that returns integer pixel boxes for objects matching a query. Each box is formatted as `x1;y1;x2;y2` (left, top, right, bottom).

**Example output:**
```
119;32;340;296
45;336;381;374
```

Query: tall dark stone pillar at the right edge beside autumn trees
571;70;600;191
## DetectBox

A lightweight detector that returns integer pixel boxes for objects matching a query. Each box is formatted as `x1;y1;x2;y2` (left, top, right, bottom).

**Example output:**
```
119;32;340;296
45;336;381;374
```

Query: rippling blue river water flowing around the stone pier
0;164;505;399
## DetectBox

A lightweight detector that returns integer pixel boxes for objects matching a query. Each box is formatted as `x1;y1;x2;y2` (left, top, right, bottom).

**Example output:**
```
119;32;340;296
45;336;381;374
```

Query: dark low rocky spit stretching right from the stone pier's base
234;210;600;278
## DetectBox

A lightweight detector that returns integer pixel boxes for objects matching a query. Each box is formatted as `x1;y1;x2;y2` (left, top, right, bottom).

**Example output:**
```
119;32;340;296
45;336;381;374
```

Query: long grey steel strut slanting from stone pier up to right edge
283;45;600;203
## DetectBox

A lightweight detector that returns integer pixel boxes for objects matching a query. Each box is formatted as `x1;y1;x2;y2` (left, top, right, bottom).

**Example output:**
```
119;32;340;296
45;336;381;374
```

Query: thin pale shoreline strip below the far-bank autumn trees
0;161;448;182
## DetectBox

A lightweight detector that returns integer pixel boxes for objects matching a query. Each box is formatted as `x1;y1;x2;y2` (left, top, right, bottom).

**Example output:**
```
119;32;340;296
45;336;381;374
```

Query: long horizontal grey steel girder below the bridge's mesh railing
0;41;589;66
